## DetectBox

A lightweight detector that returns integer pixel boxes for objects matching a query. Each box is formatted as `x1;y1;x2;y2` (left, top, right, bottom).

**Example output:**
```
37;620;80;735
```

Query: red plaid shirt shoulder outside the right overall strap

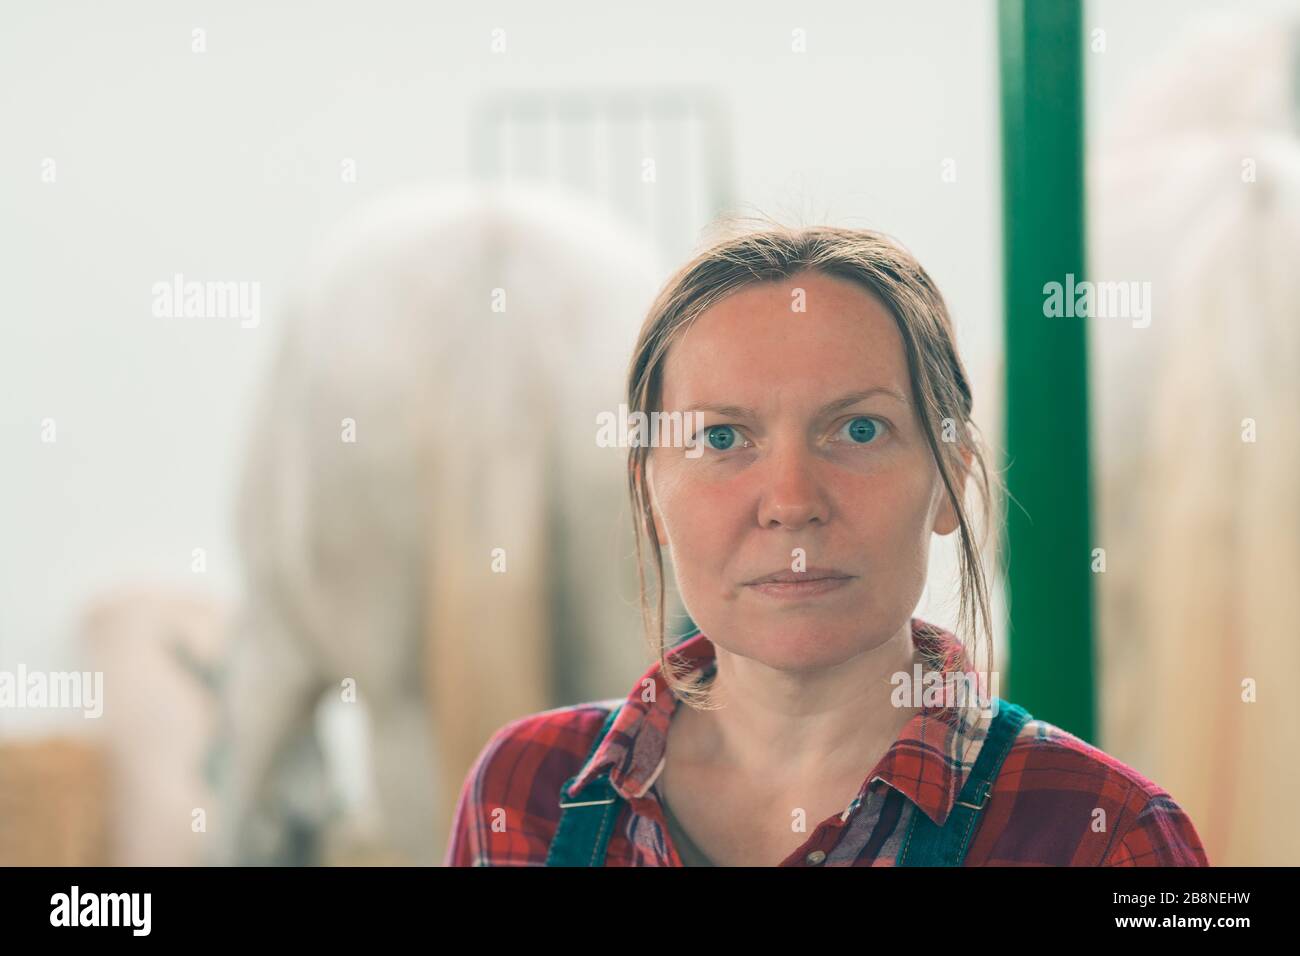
993;718;1209;866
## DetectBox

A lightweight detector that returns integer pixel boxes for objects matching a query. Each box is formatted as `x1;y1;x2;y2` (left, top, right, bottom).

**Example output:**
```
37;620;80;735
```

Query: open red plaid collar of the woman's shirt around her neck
568;618;989;826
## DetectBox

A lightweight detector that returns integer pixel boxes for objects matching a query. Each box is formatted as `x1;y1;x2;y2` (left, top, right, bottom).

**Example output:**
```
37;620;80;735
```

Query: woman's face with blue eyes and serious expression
647;272;957;671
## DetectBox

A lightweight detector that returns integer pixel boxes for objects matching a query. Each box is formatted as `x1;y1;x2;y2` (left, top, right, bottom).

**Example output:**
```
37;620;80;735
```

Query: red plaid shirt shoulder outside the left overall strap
445;698;623;866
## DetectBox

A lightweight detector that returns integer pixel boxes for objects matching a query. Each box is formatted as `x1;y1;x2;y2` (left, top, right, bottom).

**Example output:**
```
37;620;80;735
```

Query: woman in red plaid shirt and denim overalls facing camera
447;228;1209;866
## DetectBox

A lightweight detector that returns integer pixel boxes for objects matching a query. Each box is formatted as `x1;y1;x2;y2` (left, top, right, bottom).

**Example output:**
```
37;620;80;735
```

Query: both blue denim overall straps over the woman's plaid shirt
546;697;1032;866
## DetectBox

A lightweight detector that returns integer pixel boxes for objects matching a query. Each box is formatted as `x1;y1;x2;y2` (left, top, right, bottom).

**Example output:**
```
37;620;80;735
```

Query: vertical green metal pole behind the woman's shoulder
998;0;1095;740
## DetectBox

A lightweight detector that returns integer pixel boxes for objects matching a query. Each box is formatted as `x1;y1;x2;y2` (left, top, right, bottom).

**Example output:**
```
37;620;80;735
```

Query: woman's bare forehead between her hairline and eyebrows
662;272;911;408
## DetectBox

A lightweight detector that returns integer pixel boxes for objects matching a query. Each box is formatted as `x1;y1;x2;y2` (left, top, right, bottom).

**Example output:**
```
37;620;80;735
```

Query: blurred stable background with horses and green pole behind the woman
0;0;1300;865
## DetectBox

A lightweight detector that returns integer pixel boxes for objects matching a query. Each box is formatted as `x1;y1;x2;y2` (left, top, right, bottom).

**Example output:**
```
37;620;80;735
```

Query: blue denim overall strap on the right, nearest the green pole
896;697;1032;866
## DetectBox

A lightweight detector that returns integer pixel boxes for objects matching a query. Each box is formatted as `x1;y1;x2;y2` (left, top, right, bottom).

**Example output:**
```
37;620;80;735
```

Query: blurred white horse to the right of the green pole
1089;17;1300;865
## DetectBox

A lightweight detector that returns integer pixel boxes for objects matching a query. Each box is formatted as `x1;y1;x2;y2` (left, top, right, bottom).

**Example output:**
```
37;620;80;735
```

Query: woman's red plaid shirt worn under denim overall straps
445;618;1210;866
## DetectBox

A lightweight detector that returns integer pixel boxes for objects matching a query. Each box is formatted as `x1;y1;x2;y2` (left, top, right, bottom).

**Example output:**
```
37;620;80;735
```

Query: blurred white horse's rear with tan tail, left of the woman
217;180;659;864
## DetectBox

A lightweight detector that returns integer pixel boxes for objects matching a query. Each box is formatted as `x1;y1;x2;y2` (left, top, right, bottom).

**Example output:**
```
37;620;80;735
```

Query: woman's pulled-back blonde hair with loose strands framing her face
628;221;1001;709
